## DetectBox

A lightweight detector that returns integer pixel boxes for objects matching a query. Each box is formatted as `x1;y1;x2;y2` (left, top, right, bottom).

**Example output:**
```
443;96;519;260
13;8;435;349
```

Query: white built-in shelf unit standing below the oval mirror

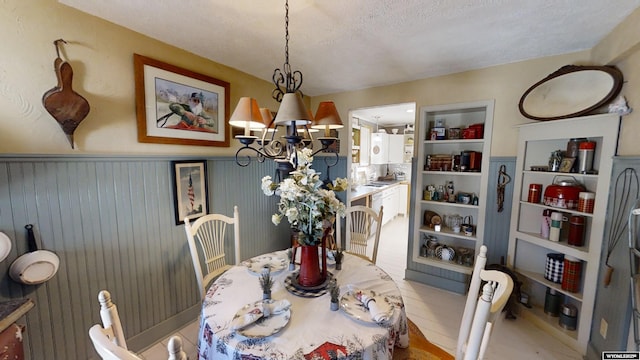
507;114;620;355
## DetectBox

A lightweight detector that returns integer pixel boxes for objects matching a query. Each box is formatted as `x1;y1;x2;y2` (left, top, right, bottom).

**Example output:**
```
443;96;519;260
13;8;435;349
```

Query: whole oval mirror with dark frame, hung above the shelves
518;65;622;120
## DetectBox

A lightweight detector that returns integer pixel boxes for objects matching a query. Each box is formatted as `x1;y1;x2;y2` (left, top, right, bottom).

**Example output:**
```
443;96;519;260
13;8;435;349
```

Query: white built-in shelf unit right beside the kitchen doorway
410;100;494;291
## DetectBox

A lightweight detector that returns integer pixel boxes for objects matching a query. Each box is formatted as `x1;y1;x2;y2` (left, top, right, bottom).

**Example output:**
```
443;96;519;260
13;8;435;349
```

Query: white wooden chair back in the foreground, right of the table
455;245;513;360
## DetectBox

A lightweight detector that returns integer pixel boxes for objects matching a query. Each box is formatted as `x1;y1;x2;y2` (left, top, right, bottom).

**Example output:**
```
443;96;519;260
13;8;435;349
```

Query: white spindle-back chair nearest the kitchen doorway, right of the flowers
336;205;383;264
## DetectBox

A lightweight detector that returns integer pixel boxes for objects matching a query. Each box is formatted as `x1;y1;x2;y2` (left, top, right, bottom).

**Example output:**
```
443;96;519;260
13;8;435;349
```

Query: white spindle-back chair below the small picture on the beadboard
184;206;240;300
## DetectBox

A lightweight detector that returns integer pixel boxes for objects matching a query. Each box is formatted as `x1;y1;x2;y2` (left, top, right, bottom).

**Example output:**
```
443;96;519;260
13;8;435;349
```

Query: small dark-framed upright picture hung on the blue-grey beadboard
171;160;209;225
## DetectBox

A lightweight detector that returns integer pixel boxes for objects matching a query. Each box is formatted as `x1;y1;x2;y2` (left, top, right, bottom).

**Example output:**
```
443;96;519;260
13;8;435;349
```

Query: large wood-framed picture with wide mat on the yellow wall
133;54;230;147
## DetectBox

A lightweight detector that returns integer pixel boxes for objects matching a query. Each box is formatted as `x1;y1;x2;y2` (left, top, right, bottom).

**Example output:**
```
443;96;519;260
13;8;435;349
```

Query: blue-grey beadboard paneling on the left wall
0;155;346;360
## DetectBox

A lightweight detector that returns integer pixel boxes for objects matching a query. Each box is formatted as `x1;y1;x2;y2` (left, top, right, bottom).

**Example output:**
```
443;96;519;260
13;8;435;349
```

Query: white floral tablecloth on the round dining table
198;251;409;360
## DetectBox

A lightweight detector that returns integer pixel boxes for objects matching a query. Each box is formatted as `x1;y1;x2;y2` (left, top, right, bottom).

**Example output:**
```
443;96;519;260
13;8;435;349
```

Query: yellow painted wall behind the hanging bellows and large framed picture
0;0;277;155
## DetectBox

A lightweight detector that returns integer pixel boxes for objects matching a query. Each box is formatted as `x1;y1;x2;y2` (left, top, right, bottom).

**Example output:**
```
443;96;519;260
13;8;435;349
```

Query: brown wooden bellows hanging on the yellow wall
42;39;89;149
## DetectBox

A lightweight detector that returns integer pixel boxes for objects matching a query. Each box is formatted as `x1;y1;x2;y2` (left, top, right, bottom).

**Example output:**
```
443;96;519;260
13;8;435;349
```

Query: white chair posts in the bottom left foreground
89;290;187;360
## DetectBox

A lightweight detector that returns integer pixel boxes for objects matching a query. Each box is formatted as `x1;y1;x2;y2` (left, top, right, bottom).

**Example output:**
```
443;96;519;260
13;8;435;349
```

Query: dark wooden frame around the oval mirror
518;65;623;121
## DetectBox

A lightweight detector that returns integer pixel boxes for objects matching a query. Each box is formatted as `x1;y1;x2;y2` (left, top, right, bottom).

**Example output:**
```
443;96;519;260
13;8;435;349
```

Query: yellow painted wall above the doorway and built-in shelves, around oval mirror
311;9;640;156
